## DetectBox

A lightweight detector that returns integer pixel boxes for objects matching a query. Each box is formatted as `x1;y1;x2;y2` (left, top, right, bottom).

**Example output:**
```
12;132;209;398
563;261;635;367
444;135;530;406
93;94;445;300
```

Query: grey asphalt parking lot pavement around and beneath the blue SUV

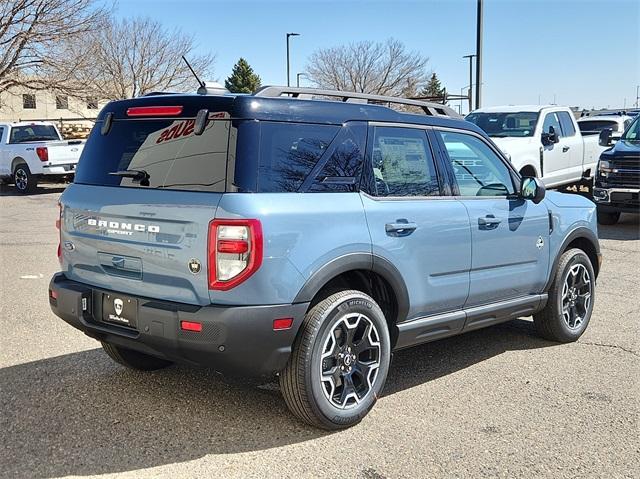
0;185;640;479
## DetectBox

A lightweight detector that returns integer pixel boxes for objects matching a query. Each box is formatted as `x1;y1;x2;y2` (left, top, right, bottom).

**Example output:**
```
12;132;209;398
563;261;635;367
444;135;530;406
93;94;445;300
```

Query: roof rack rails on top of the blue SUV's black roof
254;86;460;118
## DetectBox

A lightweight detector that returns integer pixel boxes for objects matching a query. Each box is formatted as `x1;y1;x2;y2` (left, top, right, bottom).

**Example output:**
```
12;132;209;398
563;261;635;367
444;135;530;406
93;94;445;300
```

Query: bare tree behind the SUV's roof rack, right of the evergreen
307;38;429;96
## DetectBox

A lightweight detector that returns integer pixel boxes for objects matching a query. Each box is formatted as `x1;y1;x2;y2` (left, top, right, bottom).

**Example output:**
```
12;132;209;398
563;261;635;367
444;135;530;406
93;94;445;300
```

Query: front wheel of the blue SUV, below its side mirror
533;248;595;343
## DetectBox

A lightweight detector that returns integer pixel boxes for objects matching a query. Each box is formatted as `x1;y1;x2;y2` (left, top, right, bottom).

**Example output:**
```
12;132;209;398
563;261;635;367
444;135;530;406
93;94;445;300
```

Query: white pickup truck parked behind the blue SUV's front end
466;105;606;188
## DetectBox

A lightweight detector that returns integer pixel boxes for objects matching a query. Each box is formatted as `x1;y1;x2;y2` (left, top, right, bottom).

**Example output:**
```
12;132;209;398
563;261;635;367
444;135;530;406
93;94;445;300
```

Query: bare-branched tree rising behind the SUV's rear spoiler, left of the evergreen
50;18;215;100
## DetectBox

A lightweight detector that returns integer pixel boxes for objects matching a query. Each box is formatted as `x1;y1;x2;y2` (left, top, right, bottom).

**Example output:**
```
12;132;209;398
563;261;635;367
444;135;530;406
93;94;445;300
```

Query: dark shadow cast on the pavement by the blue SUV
0;321;554;477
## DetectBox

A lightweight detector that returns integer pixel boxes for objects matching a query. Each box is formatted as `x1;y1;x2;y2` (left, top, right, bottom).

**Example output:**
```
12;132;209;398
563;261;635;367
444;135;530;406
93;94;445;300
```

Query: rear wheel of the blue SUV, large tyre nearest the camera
280;290;391;430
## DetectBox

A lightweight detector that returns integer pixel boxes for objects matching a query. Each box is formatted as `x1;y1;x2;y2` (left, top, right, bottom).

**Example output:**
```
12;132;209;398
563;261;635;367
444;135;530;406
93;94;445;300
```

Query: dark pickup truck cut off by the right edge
593;116;640;225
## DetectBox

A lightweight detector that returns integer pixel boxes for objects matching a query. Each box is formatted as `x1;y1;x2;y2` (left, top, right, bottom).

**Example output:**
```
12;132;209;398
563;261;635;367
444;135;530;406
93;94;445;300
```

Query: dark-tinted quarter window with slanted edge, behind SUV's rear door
258;121;340;193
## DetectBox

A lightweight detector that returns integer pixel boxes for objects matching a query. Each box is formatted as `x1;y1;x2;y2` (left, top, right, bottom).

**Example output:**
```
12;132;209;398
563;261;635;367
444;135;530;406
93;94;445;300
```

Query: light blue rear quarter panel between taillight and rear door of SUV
210;193;371;305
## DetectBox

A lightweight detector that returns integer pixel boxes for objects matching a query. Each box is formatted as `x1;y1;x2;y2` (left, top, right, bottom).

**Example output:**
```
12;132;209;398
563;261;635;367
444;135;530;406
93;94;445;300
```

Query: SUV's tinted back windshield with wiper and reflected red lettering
75;114;234;192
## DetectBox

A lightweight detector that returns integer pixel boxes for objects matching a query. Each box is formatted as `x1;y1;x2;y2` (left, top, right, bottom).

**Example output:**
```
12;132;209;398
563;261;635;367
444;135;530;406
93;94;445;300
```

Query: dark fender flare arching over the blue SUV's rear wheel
293;253;409;321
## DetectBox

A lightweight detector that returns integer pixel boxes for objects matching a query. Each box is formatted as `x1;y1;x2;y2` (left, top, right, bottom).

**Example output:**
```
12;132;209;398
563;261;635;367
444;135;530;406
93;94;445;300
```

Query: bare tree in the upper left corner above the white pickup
0;0;106;92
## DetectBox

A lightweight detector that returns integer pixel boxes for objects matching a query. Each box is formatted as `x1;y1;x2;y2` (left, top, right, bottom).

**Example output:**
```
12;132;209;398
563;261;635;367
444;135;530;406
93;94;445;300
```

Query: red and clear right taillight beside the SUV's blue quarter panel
208;219;262;291
